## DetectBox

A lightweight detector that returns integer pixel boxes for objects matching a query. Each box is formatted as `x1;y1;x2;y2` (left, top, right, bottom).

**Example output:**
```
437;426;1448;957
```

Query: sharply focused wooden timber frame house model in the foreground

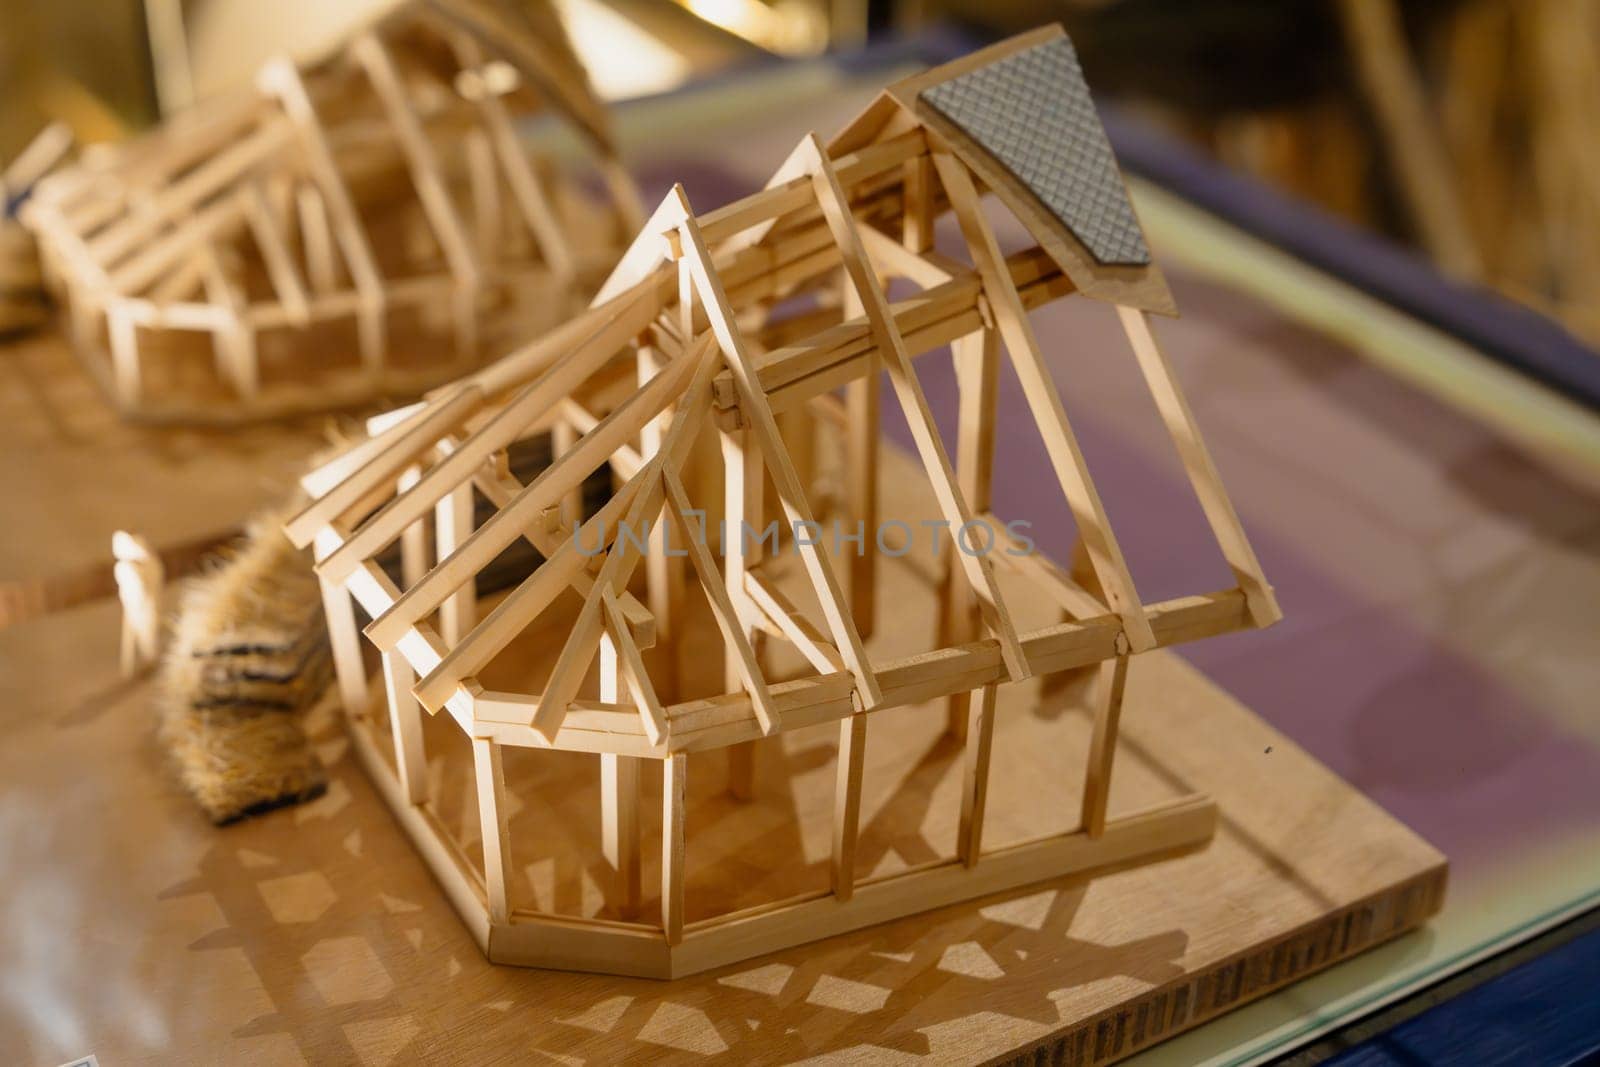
286;27;1278;977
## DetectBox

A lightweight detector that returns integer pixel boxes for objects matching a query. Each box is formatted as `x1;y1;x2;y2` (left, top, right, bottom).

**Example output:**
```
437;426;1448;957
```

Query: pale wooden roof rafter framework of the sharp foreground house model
291;22;1277;752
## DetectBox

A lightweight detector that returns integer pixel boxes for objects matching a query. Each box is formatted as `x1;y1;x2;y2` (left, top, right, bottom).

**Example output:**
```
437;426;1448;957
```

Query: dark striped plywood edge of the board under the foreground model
987;859;1448;1067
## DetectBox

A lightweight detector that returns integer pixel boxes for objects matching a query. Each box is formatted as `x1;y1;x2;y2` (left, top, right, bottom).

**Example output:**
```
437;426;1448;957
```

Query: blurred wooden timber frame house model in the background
26;0;642;421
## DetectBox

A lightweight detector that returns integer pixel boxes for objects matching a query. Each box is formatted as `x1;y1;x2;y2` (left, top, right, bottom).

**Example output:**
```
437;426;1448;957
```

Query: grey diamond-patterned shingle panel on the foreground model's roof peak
922;37;1150;266
